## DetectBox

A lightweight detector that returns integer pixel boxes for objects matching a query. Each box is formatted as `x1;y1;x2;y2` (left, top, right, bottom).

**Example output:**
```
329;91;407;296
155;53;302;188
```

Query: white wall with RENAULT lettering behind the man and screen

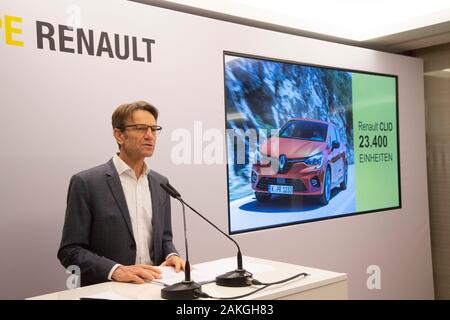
0;0;433;299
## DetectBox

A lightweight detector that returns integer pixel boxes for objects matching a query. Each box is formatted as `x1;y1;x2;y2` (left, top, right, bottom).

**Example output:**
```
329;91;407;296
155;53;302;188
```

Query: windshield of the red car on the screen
279;120;327;141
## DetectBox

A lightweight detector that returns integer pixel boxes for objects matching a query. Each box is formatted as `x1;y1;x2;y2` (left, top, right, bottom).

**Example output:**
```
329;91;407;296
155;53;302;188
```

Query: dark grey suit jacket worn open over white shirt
58;159;177;286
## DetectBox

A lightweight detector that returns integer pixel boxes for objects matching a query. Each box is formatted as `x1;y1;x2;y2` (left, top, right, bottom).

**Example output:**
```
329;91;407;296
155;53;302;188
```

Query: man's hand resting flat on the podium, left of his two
111;264;161;284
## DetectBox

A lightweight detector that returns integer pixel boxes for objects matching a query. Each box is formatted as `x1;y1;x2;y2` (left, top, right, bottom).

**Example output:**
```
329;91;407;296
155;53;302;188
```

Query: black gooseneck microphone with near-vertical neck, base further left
160;183;202;300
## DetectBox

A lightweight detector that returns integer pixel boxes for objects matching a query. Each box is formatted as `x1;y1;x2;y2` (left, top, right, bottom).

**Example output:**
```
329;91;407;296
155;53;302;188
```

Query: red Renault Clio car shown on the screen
251;118;348;205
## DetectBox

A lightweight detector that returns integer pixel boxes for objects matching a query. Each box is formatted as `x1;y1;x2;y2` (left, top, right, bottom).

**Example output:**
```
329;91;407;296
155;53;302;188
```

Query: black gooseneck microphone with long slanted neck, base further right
160;182;253;287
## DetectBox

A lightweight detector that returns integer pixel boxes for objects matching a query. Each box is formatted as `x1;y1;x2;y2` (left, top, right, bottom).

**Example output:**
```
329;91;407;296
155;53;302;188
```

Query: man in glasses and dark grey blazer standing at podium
58;101;184;286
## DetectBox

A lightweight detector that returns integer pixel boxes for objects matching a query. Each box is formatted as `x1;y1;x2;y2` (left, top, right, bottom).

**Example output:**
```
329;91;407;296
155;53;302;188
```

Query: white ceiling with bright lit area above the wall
130;0;450;52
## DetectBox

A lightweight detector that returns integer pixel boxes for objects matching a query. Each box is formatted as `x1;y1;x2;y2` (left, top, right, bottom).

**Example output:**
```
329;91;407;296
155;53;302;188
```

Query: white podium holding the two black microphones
28;257;348;300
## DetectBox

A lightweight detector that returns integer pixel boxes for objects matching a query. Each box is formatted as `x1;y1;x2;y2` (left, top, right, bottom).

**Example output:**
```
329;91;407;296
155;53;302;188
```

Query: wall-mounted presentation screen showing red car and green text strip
224;52;401;234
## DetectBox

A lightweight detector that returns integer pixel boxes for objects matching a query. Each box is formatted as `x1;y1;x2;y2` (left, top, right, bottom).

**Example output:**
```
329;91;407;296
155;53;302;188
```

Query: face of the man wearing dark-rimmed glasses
116;110;156;159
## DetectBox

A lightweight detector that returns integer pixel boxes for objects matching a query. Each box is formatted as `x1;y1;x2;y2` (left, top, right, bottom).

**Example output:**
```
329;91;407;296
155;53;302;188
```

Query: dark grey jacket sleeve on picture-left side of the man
58;175;117;286
